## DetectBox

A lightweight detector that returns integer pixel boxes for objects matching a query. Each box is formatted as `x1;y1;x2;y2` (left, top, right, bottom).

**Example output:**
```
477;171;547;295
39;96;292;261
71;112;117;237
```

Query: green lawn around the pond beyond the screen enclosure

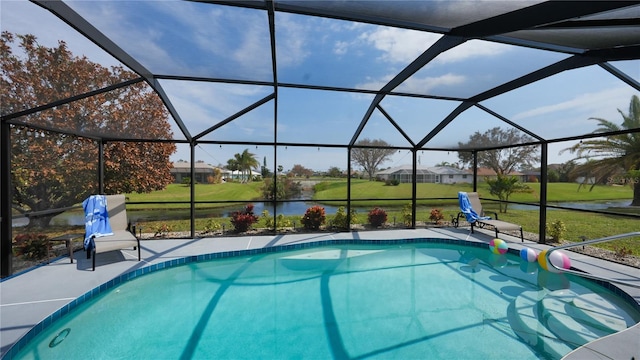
14;179;640;256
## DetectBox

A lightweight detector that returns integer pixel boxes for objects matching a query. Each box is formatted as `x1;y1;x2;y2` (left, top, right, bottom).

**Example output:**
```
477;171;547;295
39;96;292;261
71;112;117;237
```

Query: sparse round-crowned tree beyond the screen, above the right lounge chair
458;127;540;175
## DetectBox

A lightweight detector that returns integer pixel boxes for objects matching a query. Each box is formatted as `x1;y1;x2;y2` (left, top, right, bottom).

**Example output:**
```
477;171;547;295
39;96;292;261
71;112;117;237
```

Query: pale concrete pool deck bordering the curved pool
0;228;640;360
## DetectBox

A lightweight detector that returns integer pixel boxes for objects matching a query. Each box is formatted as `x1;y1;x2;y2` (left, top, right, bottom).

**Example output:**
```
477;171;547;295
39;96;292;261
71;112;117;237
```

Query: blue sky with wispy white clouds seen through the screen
0;0;640;171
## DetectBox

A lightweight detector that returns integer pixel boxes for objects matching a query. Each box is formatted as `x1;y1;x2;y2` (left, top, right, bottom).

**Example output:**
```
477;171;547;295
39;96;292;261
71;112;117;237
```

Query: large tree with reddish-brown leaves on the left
0;32;176;227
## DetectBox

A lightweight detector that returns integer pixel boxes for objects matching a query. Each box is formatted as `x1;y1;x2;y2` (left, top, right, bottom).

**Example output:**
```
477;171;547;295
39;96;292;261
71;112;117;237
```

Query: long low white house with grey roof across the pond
375;165;473;184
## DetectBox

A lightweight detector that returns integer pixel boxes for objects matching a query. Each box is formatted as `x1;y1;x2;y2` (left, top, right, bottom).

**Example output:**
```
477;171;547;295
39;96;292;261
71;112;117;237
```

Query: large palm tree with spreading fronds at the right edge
562;95;640;206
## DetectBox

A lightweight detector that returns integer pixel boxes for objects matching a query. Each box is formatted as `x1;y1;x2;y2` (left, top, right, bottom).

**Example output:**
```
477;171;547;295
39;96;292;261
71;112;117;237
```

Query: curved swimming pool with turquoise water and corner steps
6;241;640;359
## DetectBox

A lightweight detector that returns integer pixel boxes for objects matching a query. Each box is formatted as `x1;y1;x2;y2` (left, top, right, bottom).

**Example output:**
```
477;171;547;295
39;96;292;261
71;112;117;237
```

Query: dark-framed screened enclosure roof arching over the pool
2;0;640;158
